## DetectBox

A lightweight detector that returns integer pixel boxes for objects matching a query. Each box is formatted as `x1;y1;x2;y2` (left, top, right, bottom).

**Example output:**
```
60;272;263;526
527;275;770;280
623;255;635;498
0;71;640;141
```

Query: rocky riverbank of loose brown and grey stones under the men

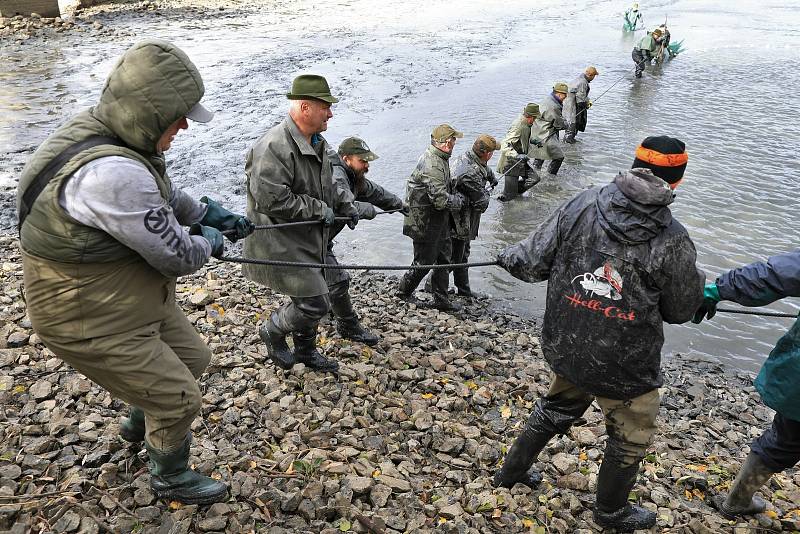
0;236;800;534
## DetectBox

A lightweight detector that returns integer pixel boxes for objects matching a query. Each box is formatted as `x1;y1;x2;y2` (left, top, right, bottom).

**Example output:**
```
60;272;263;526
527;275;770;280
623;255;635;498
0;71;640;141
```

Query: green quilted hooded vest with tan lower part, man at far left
17;39;205;340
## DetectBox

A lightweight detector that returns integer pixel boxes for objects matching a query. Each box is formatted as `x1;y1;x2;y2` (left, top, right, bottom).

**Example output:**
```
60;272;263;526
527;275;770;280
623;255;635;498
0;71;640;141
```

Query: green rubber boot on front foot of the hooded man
145;434;228;504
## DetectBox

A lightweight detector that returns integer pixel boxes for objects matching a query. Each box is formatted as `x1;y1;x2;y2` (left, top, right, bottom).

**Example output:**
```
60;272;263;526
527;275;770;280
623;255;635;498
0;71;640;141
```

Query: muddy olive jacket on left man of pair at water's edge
403;145;460;242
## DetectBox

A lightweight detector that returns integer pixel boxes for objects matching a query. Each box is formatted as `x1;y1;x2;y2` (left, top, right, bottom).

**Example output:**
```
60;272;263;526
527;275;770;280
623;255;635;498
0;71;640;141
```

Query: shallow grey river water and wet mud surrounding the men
0;0;800;370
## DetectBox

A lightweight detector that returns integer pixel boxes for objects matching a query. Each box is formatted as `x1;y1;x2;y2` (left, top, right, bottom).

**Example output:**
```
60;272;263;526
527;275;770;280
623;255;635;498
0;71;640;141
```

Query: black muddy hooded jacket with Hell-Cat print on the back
498;169;705;399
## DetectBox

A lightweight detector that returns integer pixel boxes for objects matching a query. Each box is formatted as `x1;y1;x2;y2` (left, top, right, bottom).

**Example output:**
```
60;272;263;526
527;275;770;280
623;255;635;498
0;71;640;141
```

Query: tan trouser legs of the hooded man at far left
41;306;211;451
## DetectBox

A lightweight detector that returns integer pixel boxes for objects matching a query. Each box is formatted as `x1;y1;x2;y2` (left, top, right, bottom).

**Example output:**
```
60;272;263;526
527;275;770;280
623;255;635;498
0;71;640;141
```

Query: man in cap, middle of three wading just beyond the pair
531;82;569;175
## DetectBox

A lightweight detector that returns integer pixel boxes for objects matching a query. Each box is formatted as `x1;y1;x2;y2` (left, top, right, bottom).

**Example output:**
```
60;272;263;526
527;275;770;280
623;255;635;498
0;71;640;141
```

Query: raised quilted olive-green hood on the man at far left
91;39;205;154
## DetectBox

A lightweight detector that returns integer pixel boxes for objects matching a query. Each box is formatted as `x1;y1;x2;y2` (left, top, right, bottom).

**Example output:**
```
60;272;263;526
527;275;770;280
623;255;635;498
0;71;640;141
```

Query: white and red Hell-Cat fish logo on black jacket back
564;262;636;321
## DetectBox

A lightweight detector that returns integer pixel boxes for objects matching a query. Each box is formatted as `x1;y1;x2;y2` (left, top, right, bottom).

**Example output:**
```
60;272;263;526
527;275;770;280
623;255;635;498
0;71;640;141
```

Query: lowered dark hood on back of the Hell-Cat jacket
595;169;674;245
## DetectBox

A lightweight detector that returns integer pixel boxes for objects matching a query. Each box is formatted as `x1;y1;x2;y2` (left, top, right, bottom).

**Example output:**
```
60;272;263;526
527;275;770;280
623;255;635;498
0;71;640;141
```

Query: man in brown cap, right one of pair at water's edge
450;134;500;298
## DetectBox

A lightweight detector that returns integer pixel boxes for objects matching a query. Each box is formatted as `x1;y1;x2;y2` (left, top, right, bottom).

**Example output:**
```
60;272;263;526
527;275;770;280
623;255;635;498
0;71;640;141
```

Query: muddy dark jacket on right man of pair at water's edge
451;148;497;241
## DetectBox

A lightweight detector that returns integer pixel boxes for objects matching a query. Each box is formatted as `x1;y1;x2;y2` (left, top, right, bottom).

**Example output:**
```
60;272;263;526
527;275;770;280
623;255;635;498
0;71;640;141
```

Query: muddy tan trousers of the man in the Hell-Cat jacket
525;373;660;467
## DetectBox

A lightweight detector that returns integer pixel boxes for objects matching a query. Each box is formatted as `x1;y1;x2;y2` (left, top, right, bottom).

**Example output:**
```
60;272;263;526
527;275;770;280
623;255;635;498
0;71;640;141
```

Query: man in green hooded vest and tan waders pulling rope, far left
17;39;253;503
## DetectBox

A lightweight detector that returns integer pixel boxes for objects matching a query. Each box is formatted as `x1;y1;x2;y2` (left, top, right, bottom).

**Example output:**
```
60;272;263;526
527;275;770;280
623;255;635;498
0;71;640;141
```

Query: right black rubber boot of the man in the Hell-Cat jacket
594;460;656;532
